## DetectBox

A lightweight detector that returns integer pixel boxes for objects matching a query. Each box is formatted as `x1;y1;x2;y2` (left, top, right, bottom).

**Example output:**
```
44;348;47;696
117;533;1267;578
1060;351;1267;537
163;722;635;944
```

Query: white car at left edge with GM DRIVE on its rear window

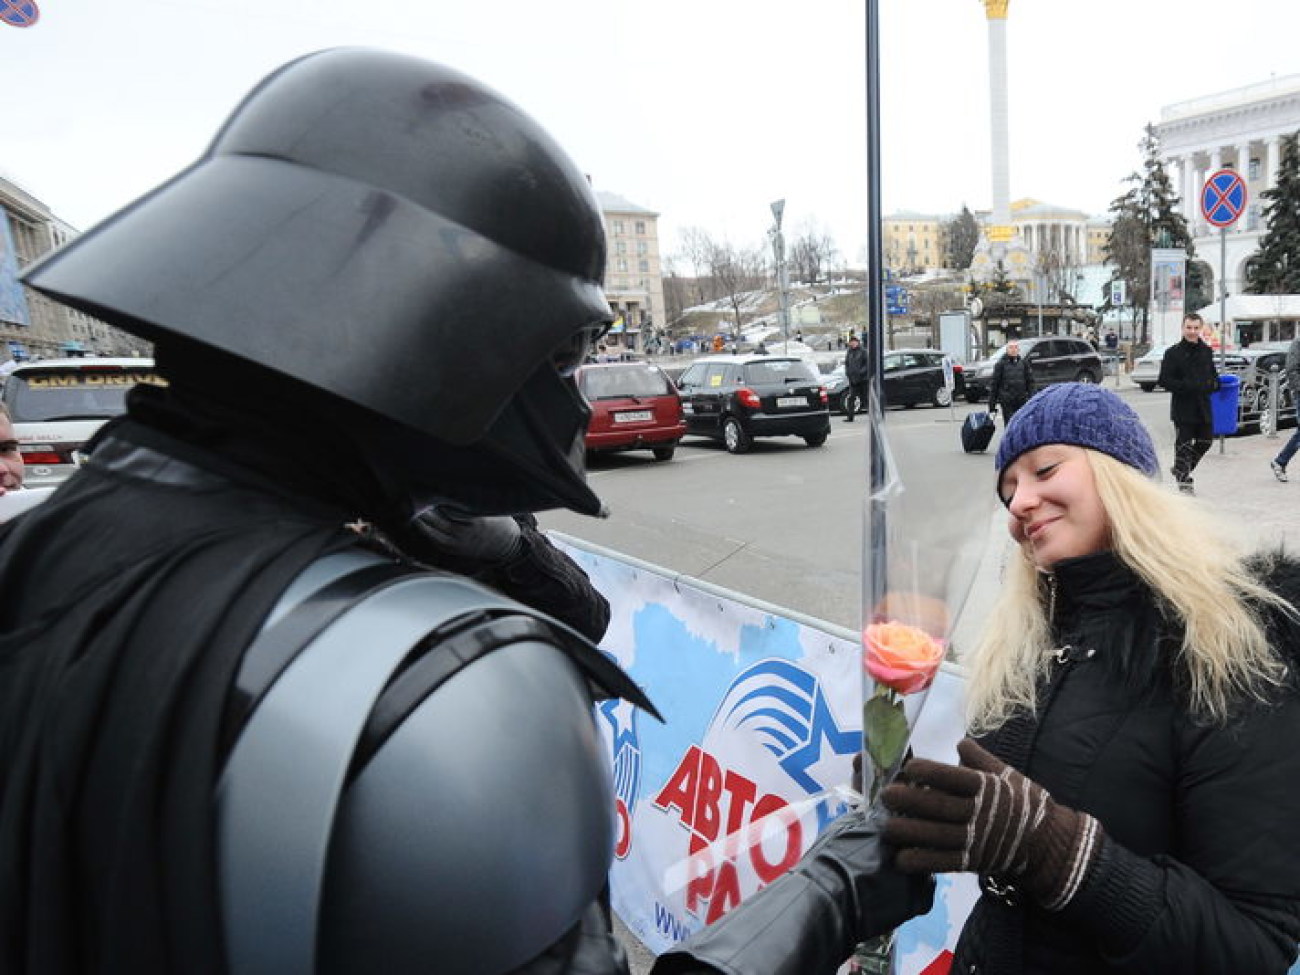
3;358;165;488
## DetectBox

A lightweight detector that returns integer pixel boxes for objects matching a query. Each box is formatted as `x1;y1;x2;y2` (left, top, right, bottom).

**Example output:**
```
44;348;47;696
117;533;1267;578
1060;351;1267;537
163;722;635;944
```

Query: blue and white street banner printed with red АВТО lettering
555;537;978;975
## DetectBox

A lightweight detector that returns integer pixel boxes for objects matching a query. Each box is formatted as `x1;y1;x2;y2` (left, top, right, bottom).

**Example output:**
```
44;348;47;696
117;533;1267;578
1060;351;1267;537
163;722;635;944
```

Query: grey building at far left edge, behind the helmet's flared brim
0;177;139;360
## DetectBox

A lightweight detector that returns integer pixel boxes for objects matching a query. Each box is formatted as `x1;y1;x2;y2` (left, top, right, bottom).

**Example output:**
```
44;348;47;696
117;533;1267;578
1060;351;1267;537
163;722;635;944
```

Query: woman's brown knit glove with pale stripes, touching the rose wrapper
881;738;1102;911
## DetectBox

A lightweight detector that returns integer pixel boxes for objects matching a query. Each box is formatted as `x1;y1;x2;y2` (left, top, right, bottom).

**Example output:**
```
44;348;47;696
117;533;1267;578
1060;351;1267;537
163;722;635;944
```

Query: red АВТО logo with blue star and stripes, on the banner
653;660;861;923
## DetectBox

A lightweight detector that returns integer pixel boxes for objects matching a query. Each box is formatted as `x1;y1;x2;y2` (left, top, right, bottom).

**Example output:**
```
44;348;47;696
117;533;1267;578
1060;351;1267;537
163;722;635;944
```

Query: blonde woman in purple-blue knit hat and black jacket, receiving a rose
884;384;1300;975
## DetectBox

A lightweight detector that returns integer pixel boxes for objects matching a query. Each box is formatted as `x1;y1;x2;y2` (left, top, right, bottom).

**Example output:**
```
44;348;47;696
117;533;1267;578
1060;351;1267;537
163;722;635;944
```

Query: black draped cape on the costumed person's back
0;423;355;975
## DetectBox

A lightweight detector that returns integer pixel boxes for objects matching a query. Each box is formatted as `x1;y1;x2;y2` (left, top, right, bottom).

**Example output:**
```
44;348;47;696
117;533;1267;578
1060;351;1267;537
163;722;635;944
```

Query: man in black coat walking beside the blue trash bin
1158;312;1218;494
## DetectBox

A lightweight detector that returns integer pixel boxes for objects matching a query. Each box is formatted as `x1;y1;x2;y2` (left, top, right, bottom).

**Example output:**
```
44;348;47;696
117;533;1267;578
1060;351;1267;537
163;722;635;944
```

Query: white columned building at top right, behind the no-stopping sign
1156;74;1300;305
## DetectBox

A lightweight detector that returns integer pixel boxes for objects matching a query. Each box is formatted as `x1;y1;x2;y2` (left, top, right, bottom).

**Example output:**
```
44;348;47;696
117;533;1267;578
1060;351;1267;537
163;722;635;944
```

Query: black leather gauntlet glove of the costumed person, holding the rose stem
651;810;935;975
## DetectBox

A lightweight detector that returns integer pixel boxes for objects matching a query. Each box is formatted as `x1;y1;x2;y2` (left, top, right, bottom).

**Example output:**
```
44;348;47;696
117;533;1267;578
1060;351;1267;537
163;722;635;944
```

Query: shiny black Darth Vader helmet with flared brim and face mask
25;49;612;514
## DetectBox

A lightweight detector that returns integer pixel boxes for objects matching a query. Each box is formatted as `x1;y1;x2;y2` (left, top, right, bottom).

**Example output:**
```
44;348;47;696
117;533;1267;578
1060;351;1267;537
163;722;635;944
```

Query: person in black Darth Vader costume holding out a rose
0;49;931;975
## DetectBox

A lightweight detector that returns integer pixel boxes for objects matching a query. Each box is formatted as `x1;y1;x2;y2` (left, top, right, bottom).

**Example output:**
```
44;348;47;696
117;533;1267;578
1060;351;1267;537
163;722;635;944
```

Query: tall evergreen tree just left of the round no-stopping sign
1105;124;1209;342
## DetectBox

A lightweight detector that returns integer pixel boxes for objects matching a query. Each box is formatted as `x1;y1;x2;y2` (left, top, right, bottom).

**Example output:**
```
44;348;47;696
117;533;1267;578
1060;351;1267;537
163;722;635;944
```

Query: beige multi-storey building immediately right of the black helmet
595;190;668;352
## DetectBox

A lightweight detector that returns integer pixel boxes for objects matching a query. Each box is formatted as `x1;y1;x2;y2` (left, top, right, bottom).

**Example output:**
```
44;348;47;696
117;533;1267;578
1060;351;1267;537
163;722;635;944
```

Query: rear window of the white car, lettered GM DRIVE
4;369;163;424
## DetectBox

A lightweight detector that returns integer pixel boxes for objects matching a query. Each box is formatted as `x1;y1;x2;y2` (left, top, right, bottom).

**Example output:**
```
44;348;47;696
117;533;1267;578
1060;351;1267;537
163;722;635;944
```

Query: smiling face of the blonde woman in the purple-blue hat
997;443;1110;571
